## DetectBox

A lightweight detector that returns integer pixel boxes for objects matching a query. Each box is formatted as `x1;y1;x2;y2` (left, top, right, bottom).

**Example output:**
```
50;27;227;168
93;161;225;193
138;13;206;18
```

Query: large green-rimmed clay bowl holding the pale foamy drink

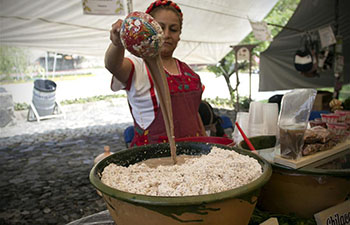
90;142;271;225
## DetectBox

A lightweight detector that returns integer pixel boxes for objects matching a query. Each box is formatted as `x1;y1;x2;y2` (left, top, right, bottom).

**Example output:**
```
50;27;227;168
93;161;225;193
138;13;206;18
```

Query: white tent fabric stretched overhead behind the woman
0;0;277;64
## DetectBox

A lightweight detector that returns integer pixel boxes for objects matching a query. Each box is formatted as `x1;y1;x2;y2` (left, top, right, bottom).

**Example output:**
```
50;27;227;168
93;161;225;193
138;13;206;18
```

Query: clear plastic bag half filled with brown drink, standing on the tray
277;89;317;160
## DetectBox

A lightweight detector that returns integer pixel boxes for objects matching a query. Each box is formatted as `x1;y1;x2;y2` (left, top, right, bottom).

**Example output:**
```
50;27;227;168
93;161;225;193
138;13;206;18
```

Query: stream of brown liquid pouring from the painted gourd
144;55;176;164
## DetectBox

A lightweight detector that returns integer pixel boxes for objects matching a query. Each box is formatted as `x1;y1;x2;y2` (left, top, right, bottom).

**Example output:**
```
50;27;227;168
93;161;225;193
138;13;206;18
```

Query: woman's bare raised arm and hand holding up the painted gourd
105;20;132;83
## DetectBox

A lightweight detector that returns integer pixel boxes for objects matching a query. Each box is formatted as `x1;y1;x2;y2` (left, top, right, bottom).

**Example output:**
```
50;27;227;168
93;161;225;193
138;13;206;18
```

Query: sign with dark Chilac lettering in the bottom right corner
314;200;350;225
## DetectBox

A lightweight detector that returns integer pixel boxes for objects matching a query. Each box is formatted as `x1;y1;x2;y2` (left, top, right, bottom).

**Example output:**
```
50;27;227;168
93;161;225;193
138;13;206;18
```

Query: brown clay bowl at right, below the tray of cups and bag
258;165;350;218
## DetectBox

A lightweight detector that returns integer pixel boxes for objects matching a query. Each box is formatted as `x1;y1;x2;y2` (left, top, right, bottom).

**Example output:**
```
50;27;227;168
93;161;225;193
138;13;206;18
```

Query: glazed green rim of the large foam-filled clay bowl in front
89;142;272;206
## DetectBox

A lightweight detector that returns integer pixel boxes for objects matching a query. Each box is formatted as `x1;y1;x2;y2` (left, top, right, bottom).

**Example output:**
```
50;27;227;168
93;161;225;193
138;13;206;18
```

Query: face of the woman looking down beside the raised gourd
153;9;181;57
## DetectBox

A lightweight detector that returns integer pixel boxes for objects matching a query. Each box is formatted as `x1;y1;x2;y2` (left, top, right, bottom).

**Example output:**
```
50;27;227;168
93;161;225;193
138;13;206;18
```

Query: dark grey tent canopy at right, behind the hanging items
259;0;350;91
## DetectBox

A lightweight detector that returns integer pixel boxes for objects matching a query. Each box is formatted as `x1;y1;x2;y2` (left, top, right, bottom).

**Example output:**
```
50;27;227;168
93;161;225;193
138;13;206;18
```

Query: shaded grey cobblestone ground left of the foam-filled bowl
0;133;125;225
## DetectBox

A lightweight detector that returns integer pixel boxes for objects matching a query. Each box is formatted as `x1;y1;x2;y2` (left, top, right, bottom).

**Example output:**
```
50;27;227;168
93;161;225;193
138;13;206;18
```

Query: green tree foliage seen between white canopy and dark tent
207;0;300;108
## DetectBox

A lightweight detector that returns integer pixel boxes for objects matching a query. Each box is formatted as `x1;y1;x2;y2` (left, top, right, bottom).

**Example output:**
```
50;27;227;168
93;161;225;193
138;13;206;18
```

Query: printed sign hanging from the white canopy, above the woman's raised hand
82;0;132;16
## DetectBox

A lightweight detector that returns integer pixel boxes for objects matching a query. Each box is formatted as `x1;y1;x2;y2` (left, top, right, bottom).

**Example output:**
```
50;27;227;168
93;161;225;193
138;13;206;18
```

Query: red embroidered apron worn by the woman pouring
131;61;202;146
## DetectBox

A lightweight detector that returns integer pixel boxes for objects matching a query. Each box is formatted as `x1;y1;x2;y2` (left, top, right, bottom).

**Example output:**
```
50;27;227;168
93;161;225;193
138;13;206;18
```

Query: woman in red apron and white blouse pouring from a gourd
105;0;205;145
